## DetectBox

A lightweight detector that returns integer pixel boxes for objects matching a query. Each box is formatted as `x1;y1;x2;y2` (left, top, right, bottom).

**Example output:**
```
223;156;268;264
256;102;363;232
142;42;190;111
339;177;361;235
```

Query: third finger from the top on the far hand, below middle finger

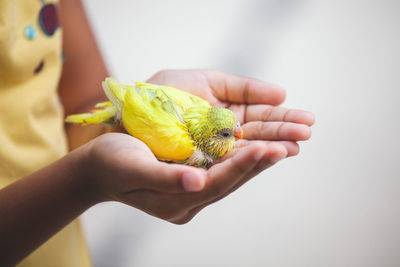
242;121;311;141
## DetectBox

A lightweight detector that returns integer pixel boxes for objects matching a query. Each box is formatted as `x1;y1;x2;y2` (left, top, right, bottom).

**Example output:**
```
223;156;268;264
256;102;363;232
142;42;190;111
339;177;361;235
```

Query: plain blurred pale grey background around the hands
79;0;400;267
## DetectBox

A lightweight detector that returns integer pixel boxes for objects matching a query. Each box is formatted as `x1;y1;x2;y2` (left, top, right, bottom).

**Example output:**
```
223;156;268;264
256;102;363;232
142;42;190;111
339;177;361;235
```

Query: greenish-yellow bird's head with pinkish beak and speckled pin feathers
185;107;243;158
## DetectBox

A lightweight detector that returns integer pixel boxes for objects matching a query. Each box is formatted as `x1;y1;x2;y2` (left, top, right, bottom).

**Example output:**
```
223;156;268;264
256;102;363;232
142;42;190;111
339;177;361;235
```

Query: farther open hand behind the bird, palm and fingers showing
148;70;314;156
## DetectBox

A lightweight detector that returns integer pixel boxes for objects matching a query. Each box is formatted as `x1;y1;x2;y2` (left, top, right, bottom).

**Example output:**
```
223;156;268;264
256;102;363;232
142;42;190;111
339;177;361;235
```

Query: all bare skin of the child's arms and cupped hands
0;0;314;266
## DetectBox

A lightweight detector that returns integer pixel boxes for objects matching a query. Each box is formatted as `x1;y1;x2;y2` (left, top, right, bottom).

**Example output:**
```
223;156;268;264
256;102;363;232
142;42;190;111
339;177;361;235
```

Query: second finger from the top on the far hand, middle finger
244;105;315;126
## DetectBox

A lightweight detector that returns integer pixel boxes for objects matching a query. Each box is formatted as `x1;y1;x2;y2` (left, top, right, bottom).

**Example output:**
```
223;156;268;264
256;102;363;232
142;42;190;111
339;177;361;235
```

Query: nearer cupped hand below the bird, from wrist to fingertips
76;133;287;223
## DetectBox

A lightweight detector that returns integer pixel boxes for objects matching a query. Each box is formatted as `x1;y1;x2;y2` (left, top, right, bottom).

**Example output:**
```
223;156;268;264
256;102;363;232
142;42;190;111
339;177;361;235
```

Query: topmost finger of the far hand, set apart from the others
203;71;286;105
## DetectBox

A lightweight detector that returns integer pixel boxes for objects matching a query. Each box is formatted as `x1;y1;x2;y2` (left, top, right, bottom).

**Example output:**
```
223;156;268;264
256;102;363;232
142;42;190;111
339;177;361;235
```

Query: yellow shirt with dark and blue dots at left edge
0;0;90;267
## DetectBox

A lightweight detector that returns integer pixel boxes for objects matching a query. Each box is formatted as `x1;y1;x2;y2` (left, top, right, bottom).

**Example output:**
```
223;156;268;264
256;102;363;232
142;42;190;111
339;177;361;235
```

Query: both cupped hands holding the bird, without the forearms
84;70;314;224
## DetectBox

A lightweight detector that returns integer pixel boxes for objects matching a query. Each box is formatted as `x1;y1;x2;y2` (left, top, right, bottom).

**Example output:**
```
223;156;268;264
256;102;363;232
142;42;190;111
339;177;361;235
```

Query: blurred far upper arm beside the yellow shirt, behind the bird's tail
59;0;108;149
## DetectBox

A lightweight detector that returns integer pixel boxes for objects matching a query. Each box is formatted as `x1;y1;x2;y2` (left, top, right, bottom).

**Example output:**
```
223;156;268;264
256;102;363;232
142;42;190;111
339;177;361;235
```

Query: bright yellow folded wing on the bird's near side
122;84;196;161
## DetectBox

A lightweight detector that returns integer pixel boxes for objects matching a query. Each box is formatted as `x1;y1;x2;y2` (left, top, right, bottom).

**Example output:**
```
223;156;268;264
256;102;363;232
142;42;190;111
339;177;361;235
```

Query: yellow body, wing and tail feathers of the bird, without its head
66;78;231;164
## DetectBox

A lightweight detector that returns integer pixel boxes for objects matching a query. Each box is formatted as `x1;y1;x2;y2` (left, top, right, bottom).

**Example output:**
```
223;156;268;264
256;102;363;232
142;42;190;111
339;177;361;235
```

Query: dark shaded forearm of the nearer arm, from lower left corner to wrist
0;148;96;266
